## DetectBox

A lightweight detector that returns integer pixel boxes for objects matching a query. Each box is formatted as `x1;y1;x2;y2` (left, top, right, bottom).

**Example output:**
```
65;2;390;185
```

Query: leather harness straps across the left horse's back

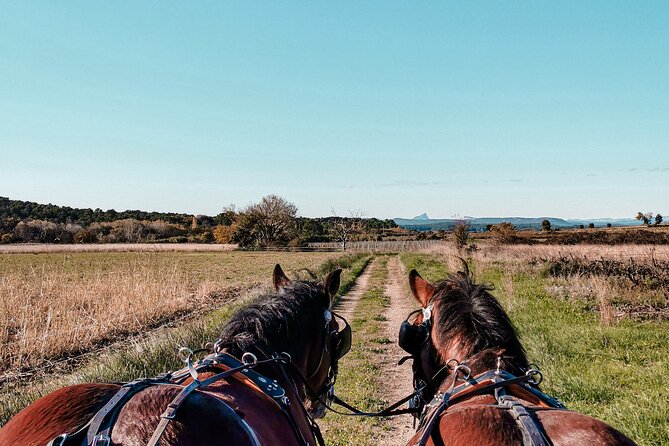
47;352;323;446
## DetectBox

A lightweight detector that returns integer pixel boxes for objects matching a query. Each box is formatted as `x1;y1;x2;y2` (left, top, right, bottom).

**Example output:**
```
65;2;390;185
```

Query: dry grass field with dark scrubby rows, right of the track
426;243;669;325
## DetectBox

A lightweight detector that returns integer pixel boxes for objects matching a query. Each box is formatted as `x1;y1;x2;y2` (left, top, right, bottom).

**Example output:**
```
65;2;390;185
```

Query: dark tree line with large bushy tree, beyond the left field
0;195;397;248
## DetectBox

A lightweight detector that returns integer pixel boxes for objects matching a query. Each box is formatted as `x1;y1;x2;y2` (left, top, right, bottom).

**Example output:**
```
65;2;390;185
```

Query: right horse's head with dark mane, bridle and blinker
400;264;527;412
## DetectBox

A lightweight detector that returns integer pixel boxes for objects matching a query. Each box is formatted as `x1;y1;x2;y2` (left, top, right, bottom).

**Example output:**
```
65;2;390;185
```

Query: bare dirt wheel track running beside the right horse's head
379;256;417;446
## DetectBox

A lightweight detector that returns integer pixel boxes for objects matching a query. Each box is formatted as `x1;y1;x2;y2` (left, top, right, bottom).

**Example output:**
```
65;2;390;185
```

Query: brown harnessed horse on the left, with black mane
0;265;351;446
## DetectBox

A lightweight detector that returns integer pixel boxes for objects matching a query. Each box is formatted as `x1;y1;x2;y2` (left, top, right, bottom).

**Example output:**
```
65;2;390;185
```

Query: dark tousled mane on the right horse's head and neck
433;262;528;369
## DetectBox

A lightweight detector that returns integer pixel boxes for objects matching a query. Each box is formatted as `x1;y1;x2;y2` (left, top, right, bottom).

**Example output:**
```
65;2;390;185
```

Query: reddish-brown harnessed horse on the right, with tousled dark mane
399;264;635;446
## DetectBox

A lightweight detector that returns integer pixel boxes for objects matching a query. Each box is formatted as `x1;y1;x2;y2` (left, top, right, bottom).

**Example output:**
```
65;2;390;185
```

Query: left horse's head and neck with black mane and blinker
221;265;351;418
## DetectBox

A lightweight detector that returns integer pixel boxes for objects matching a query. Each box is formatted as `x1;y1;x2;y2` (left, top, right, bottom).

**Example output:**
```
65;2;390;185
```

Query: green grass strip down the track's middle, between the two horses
319;257;389;446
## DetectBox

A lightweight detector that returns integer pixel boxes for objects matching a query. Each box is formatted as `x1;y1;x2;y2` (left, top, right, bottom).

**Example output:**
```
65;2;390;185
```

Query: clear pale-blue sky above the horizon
0;0;669;218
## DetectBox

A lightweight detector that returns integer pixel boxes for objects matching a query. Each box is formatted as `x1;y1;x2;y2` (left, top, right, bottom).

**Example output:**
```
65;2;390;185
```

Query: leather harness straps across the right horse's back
416;368;566;446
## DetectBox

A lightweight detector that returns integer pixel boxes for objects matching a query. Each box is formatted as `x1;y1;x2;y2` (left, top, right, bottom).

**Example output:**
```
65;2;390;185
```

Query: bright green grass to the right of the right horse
402;255;669;446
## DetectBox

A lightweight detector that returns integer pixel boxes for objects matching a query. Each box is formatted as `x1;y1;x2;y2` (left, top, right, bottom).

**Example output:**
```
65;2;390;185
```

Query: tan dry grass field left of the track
0;252;337;380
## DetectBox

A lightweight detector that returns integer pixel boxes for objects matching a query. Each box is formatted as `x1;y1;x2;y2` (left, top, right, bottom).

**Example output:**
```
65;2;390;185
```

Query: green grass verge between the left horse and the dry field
0;254;372;426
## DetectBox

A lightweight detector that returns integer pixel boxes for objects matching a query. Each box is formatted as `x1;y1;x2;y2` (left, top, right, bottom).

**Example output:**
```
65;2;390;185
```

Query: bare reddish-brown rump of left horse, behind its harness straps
0;384;120;446
